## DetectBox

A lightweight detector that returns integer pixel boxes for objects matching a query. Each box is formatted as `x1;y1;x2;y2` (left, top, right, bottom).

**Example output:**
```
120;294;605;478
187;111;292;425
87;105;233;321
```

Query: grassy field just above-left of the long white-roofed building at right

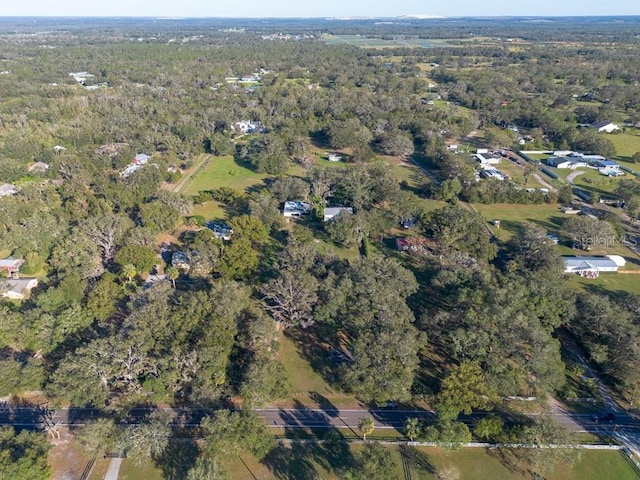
473;203;566;241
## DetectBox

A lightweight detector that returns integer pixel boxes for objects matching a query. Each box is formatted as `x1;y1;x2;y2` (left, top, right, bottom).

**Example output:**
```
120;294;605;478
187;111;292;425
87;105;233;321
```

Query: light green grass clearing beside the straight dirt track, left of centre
182;156;268;195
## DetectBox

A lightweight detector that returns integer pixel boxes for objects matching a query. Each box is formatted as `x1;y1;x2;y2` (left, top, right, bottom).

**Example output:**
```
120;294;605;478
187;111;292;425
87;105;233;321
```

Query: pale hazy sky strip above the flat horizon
0;0;640;17
